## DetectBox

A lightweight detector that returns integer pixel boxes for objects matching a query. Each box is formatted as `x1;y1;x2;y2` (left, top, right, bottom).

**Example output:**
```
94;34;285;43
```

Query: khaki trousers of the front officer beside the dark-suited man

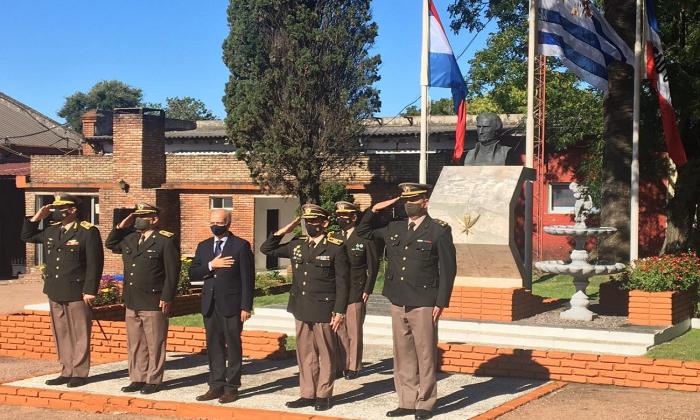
295;320;336;398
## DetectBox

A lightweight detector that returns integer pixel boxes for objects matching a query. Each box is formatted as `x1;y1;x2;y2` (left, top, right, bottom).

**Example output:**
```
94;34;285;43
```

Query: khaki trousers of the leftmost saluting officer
49;299;92;378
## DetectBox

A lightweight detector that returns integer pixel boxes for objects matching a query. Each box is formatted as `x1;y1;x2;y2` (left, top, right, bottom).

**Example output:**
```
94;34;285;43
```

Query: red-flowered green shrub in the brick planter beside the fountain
623;252;700;292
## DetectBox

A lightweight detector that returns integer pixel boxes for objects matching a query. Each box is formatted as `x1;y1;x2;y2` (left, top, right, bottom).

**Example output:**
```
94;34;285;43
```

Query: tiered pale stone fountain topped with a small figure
535;182;625;321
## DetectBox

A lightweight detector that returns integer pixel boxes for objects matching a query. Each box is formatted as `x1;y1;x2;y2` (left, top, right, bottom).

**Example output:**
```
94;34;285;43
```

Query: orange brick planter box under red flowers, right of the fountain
628;290;694;325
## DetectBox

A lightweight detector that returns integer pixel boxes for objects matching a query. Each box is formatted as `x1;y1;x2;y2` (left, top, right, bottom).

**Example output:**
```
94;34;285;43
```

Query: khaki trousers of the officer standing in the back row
336;302;367;371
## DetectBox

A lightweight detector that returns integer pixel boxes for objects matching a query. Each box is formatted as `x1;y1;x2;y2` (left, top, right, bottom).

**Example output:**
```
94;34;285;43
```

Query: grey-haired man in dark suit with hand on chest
190;209;255;404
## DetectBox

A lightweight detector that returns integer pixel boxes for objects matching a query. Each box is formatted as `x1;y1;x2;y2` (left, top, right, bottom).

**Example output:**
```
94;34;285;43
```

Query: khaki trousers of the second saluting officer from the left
124;308;168;385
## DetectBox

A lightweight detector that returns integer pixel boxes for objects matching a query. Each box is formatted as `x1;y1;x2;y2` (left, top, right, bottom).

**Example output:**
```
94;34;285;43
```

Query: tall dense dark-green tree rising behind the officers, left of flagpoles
223;0;380;203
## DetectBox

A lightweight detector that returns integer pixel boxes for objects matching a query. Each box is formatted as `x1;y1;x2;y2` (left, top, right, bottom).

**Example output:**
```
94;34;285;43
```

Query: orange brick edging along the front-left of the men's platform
0;385;336;420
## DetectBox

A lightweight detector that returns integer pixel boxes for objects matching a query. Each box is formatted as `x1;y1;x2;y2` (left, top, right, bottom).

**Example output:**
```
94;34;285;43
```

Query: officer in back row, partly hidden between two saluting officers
335;201;379;380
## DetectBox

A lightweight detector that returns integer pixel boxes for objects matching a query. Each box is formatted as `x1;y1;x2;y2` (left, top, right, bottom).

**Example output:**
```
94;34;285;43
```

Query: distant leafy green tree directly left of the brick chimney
58;80;143;131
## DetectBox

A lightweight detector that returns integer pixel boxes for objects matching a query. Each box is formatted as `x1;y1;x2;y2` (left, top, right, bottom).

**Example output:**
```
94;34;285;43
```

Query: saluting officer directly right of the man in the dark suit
260;204;350;411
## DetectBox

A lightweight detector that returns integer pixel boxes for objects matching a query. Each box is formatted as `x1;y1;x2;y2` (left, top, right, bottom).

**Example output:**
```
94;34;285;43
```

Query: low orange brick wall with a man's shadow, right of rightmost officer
438;343;700;392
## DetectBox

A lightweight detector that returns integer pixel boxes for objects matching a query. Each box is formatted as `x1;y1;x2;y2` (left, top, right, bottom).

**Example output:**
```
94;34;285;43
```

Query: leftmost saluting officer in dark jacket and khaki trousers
22;194;104;388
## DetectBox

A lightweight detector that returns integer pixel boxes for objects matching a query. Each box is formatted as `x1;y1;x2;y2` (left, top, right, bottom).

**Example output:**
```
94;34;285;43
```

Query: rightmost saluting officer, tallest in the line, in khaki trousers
357;183;457;419
